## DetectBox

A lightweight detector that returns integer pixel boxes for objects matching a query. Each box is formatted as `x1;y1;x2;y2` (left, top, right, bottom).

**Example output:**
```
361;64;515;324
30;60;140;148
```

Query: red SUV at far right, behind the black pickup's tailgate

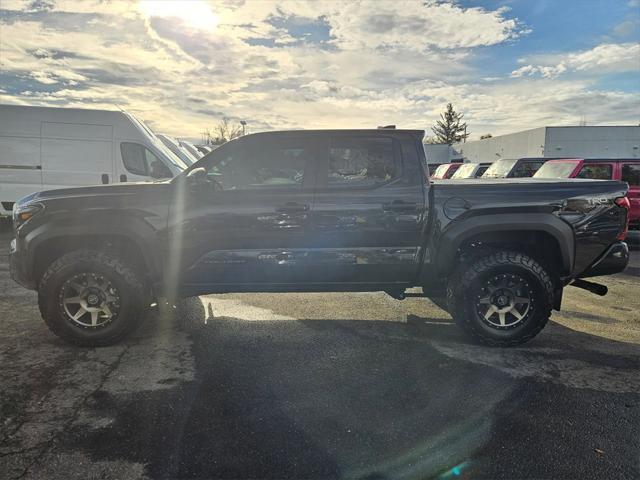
534;158;640;230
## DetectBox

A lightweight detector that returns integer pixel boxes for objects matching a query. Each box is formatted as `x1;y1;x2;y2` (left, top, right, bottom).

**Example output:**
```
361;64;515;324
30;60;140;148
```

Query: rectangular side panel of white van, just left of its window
42;122;114;189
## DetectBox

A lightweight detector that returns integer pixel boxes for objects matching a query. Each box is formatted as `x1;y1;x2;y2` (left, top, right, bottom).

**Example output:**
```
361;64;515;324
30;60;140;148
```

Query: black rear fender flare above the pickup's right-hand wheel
435;213;575;275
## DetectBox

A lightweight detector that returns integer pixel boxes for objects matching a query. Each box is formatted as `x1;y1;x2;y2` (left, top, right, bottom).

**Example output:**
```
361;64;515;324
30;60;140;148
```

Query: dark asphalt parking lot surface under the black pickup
0;231;640;479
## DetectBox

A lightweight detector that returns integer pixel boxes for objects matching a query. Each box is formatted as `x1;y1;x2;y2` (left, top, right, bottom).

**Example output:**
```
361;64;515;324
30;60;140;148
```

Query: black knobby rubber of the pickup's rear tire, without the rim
447;251;554;347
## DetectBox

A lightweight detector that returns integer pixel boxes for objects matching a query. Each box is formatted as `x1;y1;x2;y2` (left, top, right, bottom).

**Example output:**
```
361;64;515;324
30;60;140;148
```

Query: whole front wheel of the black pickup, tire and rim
38;250;150;347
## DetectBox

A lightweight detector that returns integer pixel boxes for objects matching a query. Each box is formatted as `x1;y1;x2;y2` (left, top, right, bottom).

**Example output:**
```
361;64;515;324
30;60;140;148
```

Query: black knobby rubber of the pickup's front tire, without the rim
38;250;150;347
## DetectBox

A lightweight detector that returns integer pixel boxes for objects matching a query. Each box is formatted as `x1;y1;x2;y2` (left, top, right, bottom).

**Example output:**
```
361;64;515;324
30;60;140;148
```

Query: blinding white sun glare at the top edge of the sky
140;0;220;30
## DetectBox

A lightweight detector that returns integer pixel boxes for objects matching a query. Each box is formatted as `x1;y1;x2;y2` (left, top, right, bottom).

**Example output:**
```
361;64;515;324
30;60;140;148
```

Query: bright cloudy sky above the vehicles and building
0;0;640;139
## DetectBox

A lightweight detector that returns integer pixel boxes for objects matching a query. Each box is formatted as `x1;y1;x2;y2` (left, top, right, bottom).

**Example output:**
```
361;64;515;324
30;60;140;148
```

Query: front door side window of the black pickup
208;141;313;190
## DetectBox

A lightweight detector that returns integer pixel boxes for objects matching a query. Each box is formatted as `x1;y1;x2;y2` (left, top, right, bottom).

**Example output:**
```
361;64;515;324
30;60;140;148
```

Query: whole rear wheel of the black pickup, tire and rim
447;251;553;347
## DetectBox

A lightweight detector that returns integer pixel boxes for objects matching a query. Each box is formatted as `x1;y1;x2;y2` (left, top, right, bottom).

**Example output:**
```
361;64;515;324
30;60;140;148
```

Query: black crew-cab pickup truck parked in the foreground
11;129;629;346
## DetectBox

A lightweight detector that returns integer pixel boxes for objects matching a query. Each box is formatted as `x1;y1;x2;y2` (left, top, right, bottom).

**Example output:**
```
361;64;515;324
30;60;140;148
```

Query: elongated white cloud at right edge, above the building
511;42;640;78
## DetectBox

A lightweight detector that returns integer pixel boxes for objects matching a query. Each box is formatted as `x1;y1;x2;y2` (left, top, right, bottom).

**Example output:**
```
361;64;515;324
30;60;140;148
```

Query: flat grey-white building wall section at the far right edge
544;126;640;158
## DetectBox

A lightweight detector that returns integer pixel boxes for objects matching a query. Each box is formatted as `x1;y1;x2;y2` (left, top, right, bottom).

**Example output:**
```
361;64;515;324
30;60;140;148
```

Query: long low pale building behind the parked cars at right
425;126;640;163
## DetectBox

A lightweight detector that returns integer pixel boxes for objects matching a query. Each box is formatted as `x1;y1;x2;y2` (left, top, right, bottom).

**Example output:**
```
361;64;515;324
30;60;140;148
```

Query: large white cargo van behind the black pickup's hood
0;105;186;216
